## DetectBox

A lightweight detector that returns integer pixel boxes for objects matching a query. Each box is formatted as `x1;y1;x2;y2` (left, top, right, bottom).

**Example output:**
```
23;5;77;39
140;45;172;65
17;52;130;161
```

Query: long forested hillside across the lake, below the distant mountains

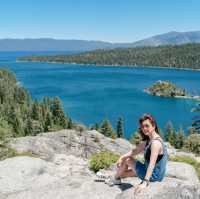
18;44;200;69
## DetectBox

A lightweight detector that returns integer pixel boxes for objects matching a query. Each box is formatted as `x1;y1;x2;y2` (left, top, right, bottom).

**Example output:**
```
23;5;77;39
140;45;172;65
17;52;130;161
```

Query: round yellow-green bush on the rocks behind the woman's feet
90;151;120;172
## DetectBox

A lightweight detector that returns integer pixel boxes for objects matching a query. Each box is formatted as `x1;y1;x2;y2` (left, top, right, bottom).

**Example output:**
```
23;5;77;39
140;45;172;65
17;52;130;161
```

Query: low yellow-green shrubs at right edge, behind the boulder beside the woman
170;156;200;179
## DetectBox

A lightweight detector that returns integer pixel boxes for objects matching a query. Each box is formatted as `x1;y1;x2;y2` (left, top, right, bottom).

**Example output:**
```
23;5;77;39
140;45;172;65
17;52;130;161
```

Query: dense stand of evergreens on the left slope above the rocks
0;69;72;137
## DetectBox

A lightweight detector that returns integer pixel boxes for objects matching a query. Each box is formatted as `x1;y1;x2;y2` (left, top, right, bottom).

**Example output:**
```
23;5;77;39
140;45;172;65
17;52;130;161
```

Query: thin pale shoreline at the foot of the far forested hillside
16;60;200;72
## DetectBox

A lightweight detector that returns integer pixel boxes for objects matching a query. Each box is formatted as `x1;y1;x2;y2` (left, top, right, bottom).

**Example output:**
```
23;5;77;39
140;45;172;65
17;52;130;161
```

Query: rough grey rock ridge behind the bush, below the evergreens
10;129;133;161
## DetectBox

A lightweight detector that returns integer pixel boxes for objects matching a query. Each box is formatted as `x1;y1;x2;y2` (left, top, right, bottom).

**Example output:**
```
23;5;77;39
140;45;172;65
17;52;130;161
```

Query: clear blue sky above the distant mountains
0;0;200;43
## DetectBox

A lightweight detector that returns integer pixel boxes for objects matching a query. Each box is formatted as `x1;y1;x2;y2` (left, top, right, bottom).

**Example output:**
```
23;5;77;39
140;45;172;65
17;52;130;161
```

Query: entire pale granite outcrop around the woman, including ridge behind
0;130;200;199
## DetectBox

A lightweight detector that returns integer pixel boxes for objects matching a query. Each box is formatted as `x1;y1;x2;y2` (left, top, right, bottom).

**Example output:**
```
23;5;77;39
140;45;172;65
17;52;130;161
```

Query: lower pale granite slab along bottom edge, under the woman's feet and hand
0;154;200;199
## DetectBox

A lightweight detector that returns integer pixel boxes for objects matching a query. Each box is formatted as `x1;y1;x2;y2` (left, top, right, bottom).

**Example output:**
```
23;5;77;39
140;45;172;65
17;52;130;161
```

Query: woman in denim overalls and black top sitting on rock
105;114;168;193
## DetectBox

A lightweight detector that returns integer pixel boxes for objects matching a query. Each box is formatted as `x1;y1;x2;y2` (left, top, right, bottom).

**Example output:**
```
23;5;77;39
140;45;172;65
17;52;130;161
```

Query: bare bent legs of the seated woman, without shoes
116;157;137;178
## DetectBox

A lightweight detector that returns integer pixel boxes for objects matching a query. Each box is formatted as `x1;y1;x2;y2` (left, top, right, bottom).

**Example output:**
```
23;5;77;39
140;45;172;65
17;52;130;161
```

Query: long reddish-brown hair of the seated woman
138;113;161;142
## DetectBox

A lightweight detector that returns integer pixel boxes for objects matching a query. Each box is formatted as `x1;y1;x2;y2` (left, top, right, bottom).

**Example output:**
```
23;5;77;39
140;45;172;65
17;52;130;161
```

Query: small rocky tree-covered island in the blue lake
144;80;200;100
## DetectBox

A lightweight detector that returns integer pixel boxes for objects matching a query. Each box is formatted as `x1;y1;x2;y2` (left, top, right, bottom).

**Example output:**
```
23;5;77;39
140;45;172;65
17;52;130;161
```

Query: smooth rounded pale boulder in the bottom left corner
0;156;58;194
